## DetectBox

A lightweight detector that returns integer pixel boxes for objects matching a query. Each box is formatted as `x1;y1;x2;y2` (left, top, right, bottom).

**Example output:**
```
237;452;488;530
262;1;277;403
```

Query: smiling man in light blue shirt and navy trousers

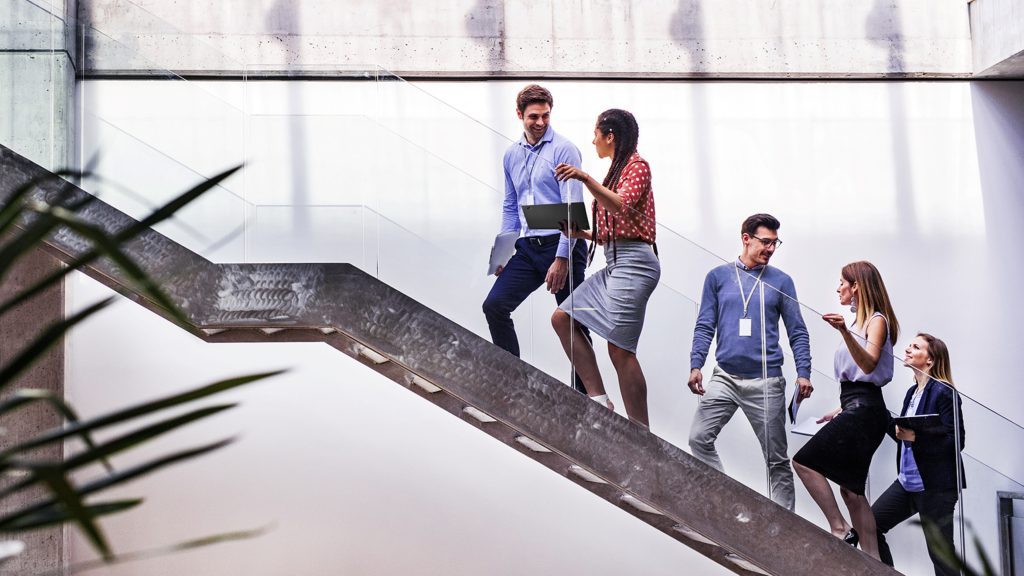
483;84;587;392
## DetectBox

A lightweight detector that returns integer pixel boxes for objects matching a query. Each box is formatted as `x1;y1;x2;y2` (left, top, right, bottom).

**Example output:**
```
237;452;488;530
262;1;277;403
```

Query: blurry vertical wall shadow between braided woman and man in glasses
669;0;718;237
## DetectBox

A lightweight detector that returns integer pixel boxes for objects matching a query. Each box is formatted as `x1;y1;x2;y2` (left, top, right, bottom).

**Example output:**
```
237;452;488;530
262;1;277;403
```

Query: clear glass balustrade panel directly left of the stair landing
79;20;246;261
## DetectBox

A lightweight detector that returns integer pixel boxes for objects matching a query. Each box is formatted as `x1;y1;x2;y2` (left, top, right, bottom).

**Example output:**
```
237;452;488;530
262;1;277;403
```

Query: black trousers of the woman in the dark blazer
871;480;959;576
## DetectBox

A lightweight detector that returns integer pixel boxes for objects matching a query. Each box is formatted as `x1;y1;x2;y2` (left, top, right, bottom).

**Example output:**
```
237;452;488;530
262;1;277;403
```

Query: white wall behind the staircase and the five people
70;82;1024;574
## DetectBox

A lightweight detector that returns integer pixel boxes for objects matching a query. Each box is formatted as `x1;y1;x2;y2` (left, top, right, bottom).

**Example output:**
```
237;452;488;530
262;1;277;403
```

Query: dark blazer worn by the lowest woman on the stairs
886;378;967;490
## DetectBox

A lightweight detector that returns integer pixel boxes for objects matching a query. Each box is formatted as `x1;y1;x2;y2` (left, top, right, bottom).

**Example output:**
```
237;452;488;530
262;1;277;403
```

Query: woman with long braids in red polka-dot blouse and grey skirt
551;109;662;426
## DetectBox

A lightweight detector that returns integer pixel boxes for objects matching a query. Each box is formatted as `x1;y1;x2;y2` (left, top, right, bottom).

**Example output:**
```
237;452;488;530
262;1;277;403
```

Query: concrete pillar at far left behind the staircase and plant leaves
0;0;78;575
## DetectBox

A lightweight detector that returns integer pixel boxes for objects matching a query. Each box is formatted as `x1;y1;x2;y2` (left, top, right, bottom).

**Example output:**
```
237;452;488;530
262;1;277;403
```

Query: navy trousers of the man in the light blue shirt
483;234;590;394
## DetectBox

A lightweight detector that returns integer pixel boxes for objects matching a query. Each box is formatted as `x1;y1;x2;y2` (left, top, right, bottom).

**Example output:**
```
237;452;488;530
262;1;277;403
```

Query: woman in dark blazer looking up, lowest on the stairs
871;334;967;576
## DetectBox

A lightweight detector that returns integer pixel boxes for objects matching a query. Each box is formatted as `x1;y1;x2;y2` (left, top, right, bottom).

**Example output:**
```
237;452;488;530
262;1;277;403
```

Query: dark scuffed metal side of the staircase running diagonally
0;140;896;576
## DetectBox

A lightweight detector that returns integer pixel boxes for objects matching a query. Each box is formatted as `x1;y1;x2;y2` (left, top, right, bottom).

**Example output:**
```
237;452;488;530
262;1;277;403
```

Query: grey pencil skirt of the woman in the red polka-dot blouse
558;240;662;354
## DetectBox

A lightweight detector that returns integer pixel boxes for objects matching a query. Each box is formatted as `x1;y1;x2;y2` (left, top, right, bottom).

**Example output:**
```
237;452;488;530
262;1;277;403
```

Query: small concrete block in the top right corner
970;0;1024;78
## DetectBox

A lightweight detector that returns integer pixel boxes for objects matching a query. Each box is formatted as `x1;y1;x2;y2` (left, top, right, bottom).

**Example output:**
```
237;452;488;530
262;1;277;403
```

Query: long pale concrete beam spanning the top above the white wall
75;0;972;78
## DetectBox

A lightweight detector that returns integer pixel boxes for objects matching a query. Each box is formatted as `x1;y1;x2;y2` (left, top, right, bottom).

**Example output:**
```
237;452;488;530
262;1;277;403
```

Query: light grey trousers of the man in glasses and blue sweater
690;366;795;510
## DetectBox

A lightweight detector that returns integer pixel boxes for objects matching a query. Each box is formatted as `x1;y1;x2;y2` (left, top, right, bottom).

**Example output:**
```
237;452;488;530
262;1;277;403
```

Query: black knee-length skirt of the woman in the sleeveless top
793;382;889;496
